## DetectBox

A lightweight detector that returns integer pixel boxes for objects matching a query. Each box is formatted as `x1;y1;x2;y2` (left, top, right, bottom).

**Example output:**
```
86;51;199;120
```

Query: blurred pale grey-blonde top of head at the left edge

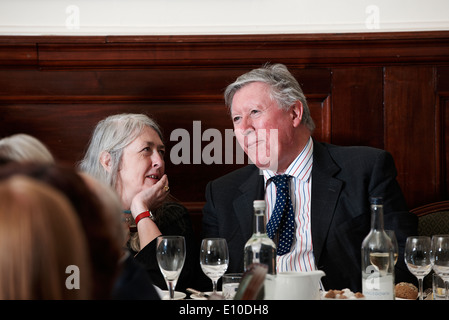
0;133;55;163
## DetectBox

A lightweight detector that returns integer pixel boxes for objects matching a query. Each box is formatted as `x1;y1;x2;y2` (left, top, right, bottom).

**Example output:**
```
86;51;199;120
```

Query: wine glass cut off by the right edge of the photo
431;234;449;300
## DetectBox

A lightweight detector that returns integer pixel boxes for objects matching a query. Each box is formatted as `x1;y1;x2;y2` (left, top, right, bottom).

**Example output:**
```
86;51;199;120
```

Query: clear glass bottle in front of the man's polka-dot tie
244;200;276;275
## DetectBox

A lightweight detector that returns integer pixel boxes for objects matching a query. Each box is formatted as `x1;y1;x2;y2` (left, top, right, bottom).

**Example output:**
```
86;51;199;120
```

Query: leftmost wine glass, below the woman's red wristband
156;236;186;300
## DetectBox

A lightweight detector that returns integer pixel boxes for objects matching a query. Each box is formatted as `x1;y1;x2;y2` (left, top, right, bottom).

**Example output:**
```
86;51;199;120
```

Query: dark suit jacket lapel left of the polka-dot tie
232;166;265;241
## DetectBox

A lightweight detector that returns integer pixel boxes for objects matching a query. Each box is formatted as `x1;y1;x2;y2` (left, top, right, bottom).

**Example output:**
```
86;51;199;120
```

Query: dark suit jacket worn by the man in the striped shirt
203;141;417;291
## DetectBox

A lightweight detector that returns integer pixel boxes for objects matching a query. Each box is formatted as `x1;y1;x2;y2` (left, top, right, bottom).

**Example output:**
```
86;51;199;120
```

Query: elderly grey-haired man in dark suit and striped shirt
203;64;417;291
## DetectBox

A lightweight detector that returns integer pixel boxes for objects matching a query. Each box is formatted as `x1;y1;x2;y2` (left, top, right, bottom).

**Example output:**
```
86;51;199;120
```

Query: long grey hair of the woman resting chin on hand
78;113;164;188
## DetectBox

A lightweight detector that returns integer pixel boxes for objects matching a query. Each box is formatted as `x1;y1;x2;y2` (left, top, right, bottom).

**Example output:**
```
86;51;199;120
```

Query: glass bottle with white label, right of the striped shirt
362;197;395;300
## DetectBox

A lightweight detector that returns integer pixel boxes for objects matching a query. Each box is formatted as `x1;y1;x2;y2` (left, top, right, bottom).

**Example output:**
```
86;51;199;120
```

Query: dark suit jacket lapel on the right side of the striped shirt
311;141;343;267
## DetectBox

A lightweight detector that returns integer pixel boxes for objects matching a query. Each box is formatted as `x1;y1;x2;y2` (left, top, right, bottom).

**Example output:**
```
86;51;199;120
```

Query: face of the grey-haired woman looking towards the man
117;127;165;204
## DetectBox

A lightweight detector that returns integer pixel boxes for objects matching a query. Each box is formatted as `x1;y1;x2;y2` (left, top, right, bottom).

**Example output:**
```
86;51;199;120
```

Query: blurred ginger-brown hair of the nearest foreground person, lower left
0;175;92;300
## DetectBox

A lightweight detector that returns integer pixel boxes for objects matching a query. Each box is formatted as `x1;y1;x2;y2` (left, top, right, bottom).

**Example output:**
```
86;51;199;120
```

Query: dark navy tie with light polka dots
267;174;295;256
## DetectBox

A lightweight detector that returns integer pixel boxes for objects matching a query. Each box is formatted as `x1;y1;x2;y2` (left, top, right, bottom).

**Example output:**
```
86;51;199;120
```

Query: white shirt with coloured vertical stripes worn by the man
263;138;316;272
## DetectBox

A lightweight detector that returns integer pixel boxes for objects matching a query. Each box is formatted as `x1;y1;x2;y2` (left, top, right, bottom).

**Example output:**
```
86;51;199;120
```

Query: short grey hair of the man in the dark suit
224;63;315;132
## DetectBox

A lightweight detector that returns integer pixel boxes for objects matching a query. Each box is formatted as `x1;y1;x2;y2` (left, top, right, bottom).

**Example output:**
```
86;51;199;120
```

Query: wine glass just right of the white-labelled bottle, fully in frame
404;236;432;300
